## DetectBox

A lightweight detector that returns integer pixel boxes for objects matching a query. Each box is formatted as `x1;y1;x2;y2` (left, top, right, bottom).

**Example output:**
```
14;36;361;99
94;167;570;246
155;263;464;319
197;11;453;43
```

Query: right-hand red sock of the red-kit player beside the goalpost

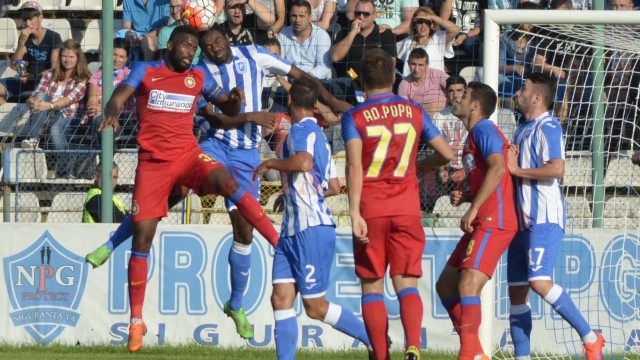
458;296;483;360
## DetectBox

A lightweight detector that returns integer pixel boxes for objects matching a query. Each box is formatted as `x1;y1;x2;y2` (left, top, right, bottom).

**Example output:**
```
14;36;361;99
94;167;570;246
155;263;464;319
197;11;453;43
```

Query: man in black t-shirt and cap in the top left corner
0;1;62;104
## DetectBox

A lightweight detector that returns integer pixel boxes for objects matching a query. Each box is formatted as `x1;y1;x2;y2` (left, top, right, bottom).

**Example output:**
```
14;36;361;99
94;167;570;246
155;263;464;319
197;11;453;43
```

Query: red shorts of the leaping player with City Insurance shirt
131;148;222;221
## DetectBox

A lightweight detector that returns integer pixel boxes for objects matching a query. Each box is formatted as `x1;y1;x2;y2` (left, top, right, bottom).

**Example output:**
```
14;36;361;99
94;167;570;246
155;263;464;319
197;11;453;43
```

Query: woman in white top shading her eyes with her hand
398;2;459;76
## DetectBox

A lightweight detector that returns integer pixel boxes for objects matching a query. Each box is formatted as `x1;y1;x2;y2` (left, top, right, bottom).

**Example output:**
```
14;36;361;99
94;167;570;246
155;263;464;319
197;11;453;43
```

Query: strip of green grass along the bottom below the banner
0;345;456;360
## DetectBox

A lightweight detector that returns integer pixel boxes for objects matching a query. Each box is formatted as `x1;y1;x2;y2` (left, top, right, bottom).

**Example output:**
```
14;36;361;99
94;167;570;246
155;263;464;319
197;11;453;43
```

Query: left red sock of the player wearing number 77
362;293;389;360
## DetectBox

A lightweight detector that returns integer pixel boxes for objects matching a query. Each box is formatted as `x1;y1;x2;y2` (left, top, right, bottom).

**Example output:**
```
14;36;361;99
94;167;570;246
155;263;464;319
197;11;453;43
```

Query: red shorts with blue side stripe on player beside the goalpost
447;228;516;278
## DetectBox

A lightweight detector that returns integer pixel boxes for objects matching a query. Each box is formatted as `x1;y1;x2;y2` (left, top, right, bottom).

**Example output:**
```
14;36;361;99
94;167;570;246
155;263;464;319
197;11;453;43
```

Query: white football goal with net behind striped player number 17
482;10;640;359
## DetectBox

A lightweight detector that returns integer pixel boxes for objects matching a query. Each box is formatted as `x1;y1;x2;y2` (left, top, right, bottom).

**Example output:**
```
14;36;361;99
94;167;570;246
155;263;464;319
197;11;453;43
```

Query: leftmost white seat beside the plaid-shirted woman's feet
4;148;47;184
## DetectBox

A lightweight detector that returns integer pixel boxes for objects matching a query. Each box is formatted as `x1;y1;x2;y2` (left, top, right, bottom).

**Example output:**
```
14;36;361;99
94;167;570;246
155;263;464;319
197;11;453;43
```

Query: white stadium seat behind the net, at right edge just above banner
602;196;640;230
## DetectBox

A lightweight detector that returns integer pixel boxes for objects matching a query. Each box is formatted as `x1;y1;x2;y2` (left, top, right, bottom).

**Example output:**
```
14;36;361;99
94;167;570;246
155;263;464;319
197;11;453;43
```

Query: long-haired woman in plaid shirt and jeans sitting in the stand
27;39;91;178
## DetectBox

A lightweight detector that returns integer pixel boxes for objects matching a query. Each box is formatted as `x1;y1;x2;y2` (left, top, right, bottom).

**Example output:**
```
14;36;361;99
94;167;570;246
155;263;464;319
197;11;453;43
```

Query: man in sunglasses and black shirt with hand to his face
331;0;396;85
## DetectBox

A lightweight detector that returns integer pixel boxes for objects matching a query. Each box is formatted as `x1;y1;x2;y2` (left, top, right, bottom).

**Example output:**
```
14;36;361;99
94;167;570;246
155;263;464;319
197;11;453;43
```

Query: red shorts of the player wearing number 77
353;215;425;279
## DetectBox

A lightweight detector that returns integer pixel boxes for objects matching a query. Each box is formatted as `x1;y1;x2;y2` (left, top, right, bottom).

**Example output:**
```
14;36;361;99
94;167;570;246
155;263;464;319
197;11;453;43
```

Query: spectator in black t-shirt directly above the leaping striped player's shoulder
222;0;275;46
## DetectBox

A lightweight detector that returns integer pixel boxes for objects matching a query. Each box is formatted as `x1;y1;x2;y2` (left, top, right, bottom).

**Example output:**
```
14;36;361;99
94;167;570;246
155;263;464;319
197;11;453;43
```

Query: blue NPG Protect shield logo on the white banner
4;231;87;344
